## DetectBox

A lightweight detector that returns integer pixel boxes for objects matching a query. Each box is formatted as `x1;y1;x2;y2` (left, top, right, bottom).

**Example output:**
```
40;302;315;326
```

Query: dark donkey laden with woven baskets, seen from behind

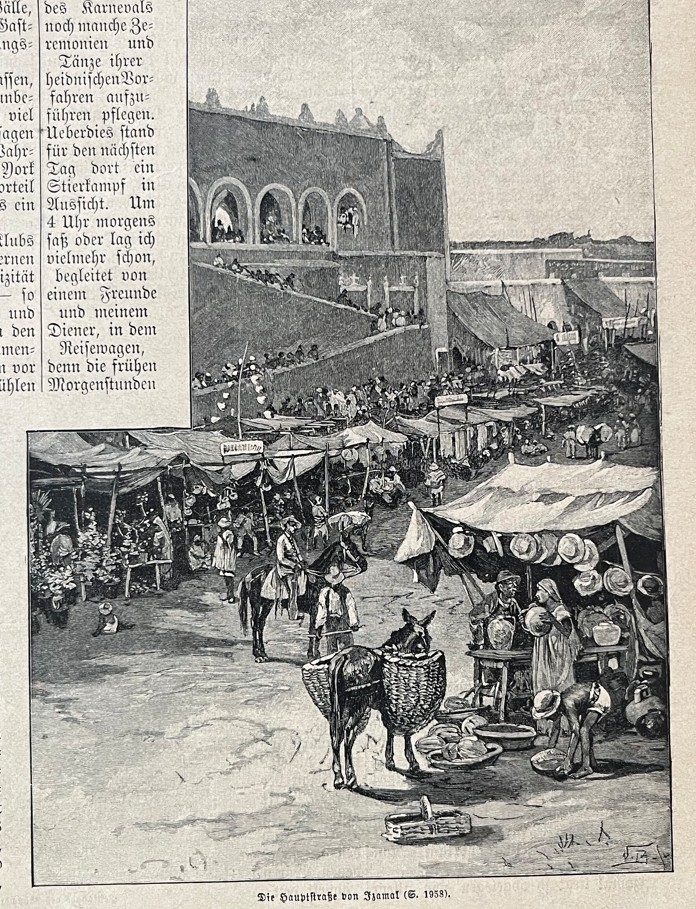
329;609;435;789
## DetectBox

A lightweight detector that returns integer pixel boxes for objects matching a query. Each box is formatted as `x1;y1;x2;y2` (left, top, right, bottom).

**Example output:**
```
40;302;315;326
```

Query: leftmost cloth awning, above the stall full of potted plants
29;432;181;492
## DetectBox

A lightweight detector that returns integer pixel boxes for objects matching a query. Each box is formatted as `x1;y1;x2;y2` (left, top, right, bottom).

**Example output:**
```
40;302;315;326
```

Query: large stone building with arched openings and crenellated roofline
189;93;449;392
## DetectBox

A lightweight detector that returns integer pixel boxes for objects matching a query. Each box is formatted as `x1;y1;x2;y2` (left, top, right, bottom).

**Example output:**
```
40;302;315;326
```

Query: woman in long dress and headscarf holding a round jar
532;578;580;694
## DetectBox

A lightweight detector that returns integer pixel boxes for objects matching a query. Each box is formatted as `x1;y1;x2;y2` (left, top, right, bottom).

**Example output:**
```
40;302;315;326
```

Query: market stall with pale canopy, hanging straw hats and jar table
395;460;666;710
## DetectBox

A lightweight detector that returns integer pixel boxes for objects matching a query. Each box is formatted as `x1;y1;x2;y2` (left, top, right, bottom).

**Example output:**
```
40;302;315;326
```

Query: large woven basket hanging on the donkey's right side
382;650;447;735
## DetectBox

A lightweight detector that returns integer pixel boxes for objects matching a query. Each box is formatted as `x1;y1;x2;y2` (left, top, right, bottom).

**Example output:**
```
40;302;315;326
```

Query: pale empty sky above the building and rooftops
189;0;653;240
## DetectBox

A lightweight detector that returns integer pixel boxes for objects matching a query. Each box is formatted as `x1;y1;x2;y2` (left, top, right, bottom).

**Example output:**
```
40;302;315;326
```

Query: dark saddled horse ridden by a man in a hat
239;538;367;663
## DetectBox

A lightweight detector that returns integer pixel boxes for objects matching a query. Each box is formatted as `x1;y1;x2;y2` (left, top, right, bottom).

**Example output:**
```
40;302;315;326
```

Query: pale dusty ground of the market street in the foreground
32;422;671;884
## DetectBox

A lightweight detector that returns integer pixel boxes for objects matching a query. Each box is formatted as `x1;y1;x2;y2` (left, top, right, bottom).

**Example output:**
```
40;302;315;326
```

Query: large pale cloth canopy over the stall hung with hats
425;461;661;539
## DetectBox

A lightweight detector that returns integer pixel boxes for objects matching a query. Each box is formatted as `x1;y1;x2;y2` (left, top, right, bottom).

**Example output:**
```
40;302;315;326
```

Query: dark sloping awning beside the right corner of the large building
447;290;553;350
